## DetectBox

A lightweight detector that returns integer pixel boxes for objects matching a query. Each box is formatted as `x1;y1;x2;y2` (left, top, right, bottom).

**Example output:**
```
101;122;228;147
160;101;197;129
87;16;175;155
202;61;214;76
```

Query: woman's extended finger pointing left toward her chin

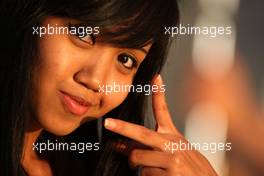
104;118;170;151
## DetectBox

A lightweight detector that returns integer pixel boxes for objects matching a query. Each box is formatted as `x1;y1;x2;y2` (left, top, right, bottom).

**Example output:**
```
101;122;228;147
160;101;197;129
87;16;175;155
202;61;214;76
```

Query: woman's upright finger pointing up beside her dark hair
152;75;179;133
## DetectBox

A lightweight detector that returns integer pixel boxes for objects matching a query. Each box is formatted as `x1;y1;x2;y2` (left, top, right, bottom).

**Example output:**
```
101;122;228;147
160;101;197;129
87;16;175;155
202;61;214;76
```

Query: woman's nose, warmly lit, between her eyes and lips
74;47;115;92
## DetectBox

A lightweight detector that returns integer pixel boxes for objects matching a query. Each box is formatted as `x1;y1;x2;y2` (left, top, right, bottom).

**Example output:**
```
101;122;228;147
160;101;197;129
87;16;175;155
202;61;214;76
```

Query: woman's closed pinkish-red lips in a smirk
60;91;91;116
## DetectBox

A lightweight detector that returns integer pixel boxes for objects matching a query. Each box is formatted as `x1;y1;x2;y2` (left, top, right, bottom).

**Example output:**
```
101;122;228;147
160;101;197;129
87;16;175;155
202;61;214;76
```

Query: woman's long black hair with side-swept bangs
0;0;179;176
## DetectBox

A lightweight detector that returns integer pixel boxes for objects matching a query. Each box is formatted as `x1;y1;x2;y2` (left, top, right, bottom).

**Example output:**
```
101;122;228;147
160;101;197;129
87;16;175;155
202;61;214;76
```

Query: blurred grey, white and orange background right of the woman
146;0;264;176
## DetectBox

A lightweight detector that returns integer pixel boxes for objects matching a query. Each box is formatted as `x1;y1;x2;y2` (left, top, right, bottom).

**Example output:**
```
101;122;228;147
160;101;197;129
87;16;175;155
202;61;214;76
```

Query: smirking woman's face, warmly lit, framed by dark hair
33;17;150;135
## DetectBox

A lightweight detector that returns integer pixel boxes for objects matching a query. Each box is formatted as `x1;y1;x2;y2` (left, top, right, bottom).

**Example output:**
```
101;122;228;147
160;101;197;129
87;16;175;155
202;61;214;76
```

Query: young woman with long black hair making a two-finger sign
0;0;216;176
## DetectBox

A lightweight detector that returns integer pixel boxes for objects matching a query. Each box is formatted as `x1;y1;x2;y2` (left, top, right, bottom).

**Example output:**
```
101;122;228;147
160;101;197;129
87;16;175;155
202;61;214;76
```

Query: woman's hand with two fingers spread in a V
105;76;217;176
